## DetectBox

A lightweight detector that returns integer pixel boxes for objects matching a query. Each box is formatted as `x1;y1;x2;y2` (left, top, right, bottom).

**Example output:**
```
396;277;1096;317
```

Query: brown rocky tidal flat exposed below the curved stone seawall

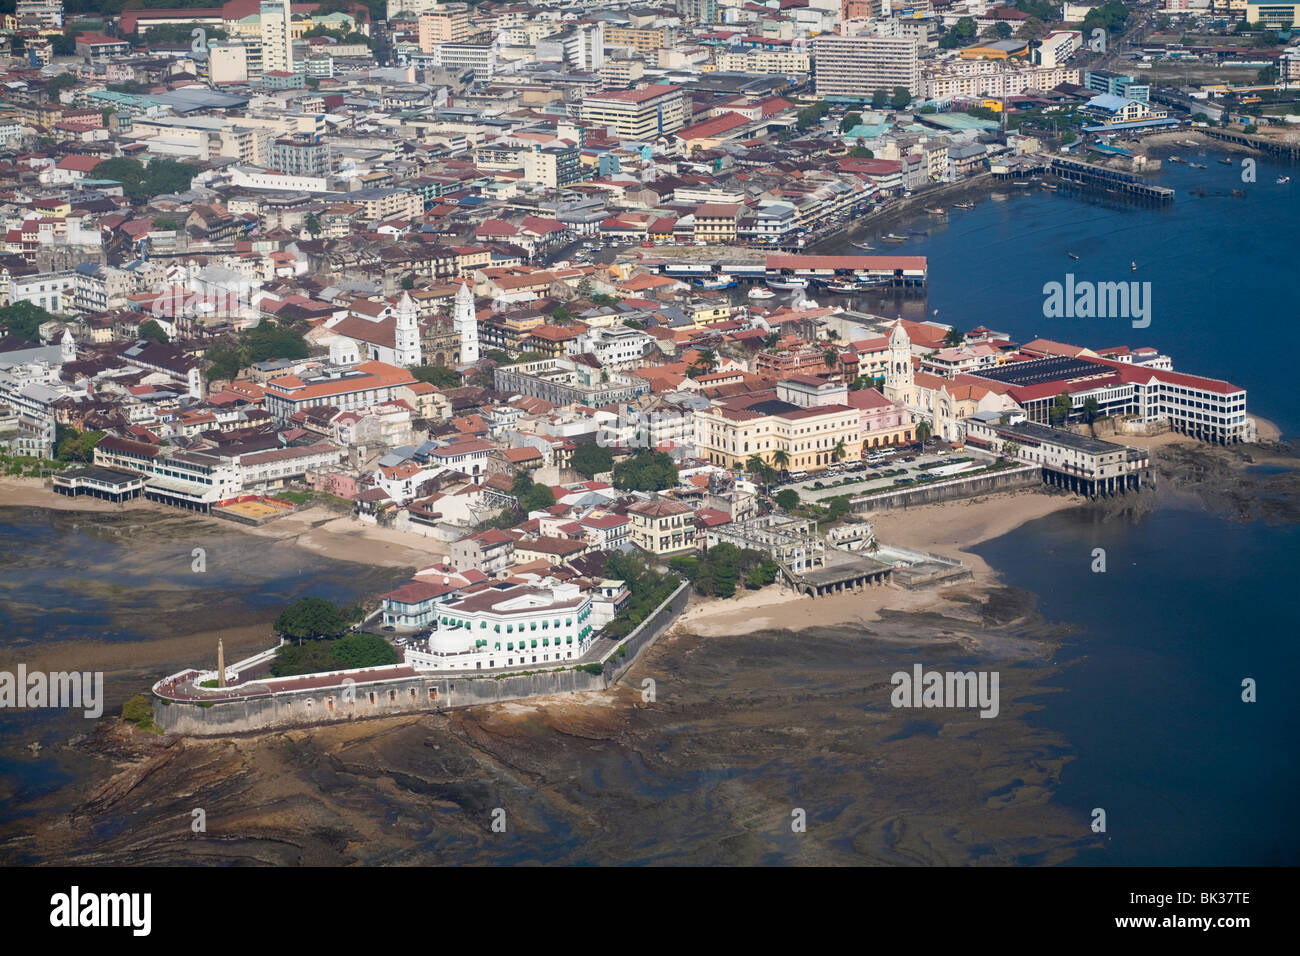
0;580;1096;865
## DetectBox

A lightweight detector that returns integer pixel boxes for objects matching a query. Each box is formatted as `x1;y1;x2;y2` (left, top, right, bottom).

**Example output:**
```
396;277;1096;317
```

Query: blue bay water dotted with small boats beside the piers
842;147;1300;434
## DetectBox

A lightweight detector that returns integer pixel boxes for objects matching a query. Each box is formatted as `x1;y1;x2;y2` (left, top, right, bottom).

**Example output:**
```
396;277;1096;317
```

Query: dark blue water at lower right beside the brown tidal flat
975;506;1300;866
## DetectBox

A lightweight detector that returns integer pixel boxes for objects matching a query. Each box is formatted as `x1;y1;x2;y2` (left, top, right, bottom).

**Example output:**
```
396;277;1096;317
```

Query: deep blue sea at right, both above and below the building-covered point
885;148;1300;865
